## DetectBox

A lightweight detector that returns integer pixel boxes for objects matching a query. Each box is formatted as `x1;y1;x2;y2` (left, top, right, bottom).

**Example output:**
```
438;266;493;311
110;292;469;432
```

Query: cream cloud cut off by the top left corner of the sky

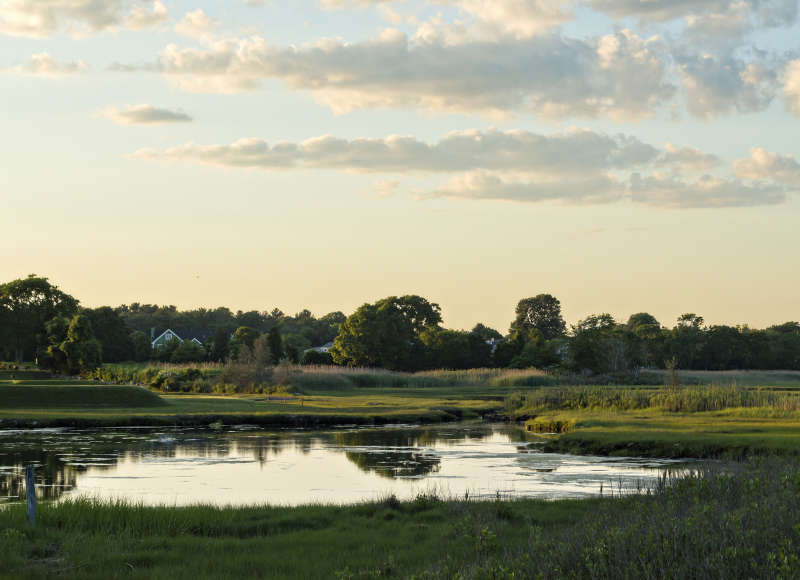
0;0;168;38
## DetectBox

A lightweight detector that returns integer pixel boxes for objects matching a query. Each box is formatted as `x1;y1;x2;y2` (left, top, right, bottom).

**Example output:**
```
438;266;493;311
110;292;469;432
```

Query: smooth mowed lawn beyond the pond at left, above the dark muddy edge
0;379;510;421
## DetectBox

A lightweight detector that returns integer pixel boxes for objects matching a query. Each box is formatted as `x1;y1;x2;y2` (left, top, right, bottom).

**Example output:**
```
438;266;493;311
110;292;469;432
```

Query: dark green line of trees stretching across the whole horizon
0;275;800;374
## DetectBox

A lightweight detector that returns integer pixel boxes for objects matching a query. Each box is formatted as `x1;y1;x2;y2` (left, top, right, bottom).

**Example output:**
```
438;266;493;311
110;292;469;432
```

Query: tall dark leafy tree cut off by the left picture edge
0;274;78;363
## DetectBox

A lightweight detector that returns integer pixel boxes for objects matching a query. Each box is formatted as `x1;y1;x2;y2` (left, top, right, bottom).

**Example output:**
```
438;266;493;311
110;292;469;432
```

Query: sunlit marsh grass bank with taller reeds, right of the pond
505;384;800;458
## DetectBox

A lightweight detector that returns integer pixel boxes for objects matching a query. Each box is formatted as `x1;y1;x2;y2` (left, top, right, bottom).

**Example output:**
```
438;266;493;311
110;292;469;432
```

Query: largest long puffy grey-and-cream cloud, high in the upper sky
140;31;675;119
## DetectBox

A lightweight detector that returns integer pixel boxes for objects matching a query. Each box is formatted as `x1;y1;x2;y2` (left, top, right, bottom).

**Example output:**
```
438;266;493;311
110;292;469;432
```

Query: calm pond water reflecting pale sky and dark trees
0;424;688;505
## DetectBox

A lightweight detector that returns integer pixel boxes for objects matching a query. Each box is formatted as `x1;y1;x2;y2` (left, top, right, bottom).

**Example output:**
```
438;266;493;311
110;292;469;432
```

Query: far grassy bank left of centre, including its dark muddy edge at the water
0;379;504;428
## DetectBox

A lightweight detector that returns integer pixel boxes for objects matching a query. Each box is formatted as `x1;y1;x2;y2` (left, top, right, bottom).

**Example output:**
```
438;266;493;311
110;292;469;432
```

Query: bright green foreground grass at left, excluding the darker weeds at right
0;496;592;580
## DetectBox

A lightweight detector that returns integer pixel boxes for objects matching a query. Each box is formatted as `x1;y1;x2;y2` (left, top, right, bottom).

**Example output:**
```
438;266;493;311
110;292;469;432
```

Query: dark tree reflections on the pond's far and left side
0;425;510;501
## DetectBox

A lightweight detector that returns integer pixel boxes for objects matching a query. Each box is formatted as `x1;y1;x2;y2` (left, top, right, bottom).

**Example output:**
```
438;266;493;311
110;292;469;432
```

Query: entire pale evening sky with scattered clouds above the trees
0;0;800;331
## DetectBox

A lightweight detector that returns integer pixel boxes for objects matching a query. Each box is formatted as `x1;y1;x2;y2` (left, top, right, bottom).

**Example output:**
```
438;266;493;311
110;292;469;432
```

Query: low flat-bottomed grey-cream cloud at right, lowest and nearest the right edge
629;174;786;209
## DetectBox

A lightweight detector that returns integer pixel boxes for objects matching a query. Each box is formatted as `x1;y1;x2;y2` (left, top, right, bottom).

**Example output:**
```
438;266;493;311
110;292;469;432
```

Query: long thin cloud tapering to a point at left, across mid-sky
128;129;659;176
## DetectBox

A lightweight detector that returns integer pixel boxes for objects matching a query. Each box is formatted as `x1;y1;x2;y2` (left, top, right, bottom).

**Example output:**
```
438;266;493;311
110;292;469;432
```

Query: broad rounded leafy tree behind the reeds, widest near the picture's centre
331;295;442;370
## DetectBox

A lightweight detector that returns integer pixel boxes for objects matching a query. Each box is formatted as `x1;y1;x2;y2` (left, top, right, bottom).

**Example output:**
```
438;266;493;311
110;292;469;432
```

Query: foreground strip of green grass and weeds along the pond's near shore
0;460;800;580
